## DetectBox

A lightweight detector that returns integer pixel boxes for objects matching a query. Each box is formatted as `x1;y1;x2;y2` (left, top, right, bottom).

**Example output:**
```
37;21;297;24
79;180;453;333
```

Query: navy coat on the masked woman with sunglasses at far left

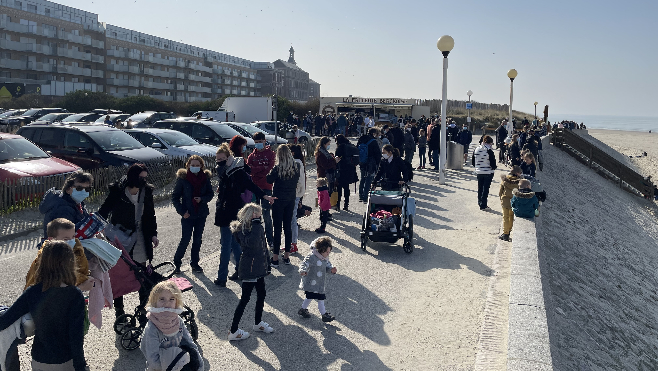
39;188;89;238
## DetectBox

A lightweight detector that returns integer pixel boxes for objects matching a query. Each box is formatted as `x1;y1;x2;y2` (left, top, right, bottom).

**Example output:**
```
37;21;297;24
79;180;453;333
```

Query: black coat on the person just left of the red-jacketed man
215;157;265;227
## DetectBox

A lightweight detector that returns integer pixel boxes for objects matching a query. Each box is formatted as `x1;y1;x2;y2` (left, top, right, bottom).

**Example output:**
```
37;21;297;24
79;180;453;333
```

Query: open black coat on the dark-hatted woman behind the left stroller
98;176;158;260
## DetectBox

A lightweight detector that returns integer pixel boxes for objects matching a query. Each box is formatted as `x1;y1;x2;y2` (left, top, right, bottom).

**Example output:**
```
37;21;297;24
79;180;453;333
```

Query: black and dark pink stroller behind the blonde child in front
110;241;199;350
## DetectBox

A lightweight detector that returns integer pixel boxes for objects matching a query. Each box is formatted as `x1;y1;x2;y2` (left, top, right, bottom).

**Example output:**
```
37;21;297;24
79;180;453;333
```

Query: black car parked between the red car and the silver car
16;125;167;169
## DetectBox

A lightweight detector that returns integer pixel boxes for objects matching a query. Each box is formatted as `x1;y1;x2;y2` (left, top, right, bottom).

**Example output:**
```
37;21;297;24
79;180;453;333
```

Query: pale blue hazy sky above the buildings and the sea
56;0;658;117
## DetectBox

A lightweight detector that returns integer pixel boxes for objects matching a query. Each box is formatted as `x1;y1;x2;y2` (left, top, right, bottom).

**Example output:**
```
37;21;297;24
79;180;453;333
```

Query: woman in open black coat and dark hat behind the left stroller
98;164;160;317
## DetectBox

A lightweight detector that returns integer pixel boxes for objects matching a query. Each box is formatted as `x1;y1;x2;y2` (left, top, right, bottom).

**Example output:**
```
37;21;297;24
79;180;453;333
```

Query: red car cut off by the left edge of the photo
0;133;80;181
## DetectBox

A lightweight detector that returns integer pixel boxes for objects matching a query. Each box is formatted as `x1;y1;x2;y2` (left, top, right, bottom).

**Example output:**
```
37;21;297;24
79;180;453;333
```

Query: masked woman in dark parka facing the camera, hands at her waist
171;155;215;274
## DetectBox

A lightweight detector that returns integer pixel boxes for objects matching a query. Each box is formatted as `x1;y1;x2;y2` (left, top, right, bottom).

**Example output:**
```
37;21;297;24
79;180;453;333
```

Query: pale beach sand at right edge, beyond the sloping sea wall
587;129;658;184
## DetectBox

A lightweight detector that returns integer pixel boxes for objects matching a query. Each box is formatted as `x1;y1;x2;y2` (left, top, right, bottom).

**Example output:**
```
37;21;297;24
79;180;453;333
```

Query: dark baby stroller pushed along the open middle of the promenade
361;183;416;254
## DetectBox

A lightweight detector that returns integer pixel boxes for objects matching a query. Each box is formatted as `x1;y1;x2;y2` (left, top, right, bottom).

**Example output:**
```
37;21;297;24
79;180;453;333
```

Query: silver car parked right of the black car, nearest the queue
124;128;217;157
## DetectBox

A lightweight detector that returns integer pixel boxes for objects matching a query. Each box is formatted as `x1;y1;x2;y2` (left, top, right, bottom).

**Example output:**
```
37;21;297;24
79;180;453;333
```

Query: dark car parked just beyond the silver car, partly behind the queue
153;120;255;152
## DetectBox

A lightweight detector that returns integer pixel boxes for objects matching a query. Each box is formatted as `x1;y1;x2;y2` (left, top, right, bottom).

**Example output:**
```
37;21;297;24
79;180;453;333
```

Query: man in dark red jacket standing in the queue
247;133;276;249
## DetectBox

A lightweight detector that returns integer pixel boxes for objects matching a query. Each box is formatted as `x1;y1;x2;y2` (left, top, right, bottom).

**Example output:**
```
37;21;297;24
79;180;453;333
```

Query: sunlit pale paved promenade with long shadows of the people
0;150;509;370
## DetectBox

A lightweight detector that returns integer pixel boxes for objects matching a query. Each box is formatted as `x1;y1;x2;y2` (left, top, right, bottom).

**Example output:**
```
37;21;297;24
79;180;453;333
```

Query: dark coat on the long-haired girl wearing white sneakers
233;220;270;280
